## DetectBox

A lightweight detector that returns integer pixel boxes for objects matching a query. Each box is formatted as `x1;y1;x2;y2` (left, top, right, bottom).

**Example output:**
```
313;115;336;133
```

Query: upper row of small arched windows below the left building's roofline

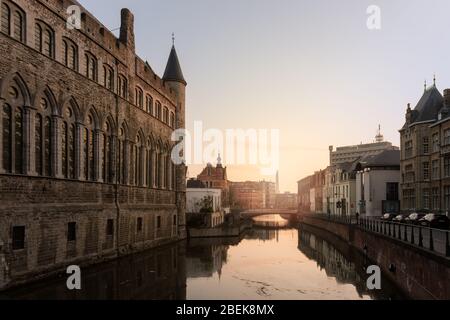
0;0;175;128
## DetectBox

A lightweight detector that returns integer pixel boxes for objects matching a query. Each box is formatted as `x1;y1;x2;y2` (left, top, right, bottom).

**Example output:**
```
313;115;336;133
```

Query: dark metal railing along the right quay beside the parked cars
357;218;450;257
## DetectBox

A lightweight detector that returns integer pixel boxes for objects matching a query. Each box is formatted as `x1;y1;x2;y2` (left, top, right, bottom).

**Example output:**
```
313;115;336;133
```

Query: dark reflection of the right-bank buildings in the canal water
298;225;406;300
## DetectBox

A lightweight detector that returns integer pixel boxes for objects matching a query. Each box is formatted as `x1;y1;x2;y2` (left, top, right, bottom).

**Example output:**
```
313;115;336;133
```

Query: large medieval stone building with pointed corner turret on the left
0;0;186;288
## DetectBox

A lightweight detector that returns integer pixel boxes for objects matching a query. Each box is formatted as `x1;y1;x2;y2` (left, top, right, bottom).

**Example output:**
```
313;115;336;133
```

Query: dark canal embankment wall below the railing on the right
302;216;450;300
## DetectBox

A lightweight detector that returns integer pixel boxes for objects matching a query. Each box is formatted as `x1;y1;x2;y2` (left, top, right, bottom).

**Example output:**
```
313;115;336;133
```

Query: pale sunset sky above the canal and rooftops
80;0;450;192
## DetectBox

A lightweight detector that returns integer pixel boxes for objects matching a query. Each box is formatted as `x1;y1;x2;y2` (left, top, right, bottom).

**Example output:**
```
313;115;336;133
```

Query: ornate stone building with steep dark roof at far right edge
400;84;450;213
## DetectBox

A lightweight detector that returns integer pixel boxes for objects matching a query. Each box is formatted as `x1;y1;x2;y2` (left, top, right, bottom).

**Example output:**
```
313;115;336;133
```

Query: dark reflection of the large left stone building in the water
0;242;186;300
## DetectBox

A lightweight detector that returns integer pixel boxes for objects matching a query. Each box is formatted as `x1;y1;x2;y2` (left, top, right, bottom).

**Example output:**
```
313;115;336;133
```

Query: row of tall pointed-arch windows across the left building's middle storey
0;74;175;190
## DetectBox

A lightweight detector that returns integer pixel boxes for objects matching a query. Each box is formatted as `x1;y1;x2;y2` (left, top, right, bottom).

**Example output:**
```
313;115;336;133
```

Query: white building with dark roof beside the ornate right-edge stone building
356;150;401;217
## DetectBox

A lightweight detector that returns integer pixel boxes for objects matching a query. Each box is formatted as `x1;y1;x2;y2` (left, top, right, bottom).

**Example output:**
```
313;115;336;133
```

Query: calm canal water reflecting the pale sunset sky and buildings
0;215;405;300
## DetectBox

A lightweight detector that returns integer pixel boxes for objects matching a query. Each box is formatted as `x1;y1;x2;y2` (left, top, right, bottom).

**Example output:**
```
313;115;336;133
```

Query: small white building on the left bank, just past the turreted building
186;188;224;228
